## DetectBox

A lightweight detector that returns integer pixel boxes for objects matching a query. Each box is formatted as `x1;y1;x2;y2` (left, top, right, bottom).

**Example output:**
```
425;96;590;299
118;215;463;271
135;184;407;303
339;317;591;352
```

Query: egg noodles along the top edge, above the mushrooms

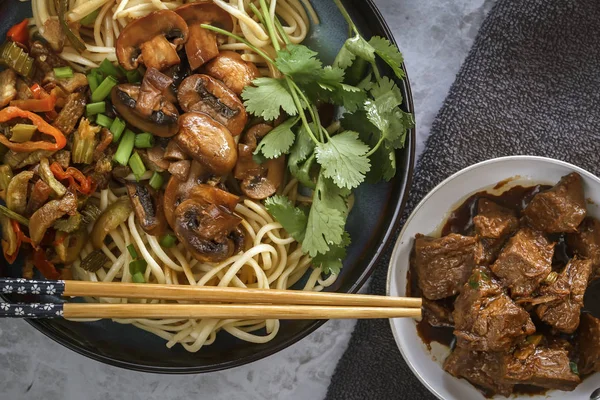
31;0;318;75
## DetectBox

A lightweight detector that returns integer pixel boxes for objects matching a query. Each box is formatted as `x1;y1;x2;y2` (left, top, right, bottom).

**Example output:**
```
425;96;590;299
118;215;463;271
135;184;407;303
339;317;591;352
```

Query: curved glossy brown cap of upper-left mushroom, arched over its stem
116;10;188;71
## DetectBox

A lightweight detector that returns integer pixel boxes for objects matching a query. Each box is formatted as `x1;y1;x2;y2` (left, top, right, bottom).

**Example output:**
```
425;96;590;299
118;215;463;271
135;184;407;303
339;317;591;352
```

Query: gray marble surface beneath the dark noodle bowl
0;0;494;400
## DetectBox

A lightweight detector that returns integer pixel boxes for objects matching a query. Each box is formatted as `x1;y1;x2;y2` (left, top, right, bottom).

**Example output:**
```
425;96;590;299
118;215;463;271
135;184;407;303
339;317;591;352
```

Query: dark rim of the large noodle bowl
12;0;416;375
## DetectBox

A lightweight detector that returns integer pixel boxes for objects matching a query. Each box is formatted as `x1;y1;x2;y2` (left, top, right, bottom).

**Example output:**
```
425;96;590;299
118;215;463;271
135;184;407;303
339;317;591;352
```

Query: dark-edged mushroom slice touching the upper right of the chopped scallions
111;83;179;137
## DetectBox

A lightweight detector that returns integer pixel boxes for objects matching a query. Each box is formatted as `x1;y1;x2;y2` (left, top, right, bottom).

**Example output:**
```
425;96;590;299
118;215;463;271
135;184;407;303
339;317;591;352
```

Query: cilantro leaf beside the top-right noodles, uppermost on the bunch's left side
275;44;323;83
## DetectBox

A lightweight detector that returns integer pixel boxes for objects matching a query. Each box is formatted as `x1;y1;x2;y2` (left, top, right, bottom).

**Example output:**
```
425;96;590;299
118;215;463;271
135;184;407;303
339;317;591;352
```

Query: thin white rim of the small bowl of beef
385;155;600;400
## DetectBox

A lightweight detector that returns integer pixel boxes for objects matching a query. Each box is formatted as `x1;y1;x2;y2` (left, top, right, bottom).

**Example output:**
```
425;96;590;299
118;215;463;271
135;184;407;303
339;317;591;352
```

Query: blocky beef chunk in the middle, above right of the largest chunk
491;228;554;298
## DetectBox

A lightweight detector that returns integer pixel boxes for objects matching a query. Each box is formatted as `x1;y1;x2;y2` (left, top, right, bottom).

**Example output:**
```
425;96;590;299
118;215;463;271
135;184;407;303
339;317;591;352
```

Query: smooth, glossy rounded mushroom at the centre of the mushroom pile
173;112;237;175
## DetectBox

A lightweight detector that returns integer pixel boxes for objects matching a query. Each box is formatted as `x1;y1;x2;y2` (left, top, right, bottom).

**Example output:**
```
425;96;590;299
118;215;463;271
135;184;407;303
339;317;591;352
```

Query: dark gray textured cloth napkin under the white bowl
327;0;600;400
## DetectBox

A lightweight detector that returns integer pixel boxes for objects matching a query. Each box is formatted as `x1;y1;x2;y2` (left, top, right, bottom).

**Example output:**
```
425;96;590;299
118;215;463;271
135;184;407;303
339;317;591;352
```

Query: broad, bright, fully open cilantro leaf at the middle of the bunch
315;131;370;189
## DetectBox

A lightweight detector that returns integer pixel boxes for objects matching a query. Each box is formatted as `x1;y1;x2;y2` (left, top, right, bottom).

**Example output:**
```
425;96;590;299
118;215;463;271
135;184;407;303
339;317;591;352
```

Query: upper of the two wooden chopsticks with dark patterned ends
0;279;422;308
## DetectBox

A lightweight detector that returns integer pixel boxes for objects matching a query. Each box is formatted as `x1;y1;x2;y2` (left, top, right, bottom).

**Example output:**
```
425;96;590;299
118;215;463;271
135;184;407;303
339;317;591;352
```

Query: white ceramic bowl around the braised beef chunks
387;156;600;400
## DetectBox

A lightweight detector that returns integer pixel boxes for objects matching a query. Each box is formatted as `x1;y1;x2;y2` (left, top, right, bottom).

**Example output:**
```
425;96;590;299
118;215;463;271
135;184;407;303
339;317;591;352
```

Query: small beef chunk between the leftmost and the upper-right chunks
473;198;519;265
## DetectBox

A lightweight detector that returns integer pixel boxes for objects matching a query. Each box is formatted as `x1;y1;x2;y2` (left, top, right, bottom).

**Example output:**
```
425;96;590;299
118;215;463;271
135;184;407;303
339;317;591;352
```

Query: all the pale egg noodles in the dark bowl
24;0;337;352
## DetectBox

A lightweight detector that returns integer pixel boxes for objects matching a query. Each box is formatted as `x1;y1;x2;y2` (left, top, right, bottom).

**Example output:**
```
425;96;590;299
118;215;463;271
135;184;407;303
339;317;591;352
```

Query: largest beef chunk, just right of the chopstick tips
452;268;535;351
